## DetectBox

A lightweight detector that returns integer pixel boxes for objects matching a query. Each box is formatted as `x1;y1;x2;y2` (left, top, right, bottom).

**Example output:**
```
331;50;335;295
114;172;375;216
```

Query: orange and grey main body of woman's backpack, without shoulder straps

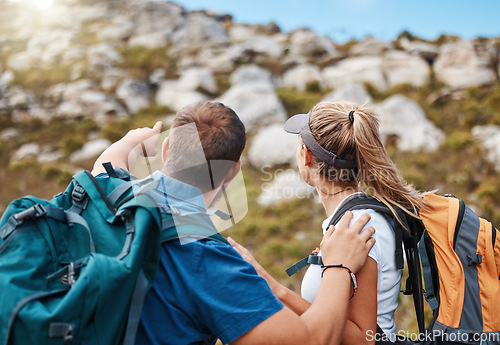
419;194;500;345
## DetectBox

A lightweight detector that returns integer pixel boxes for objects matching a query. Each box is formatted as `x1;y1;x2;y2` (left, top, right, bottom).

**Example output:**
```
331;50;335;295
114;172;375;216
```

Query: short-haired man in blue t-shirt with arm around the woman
93;102;374;345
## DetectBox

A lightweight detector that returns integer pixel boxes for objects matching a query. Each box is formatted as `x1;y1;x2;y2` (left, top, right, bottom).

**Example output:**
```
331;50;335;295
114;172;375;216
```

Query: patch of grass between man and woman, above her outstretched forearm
224;166;326;292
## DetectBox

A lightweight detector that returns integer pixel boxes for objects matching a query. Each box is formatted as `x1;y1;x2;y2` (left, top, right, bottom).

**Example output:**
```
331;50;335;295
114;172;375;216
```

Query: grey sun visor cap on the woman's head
284;113;358;169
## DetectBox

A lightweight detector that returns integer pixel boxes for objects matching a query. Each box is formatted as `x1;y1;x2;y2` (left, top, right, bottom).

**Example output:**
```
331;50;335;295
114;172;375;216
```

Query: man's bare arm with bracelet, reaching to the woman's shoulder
232;212;375;345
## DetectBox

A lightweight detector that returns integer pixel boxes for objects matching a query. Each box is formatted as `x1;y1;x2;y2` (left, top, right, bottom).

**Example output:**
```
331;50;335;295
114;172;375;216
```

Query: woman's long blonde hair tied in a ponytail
310;102;425;222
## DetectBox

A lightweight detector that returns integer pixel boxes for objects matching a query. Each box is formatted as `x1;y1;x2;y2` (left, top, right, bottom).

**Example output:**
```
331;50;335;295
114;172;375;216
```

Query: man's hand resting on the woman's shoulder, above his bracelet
320;211;375;272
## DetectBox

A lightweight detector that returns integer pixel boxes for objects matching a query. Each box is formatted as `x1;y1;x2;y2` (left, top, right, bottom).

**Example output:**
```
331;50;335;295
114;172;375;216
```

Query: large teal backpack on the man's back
0;163;225;345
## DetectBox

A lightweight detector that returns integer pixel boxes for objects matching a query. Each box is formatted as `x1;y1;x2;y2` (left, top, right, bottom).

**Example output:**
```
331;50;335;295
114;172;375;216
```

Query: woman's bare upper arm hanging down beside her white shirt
341;257;378;345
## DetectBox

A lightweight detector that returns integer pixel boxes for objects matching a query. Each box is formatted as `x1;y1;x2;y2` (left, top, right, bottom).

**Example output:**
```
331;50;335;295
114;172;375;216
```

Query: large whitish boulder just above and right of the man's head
219;65;287;131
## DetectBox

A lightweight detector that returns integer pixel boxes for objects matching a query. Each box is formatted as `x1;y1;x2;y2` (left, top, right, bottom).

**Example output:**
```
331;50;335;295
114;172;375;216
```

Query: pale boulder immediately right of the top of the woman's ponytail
373;95;445;152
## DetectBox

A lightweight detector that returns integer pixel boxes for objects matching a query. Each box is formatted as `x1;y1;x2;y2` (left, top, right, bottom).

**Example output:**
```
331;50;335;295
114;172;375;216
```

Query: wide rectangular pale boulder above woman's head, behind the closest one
322;56;387;90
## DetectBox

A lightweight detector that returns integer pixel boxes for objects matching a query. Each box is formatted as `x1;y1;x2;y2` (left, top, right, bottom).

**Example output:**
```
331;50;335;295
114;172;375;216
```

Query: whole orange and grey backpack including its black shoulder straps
287;194;500;345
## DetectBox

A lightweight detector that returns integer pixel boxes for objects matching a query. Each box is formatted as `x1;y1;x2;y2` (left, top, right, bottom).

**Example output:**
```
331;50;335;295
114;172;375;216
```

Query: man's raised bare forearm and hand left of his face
92;121;163;176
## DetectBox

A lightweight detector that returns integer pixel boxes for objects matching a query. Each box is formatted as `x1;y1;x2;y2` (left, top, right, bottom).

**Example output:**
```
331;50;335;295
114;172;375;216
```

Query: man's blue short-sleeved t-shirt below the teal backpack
135;239;283;345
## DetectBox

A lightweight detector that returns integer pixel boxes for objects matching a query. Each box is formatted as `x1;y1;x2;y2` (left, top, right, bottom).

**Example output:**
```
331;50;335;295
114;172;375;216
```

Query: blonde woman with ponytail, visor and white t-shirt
231;102;425;345
